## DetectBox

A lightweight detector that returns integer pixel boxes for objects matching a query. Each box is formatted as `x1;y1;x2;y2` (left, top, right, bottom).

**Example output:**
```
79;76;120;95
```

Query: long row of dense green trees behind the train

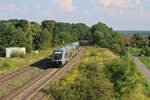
0;19;124;56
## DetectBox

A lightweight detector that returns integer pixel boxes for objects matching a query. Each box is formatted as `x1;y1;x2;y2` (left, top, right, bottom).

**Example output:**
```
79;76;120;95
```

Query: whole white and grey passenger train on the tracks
52;42;80;66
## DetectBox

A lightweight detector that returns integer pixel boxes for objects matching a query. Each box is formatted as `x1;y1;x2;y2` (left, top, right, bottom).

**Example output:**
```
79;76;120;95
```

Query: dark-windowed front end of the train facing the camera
52;49;63;66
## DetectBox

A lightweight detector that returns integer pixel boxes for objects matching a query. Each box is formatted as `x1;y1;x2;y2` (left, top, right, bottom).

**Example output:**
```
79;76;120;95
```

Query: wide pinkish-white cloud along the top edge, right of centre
97;0;140;8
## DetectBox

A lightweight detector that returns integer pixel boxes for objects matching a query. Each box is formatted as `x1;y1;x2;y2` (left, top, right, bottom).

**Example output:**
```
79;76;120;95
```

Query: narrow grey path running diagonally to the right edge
129;54;150;82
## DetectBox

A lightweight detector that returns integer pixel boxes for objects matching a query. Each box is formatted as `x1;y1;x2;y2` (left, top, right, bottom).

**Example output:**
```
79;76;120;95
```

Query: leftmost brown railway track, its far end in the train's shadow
0;59;47;85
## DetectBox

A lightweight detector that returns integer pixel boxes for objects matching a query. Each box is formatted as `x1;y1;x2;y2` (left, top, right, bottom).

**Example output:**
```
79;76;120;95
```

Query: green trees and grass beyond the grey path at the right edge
128;33;150;69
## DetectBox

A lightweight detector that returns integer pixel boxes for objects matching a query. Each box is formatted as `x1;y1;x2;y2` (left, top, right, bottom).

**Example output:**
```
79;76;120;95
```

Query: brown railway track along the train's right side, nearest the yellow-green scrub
2;47;84;100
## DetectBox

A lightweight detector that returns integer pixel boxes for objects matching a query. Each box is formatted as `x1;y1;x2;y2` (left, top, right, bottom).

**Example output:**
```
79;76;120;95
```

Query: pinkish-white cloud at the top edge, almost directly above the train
53;0;74;12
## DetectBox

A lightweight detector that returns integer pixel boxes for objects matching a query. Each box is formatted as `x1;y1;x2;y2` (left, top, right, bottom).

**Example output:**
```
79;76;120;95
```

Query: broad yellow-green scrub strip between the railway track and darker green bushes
48;47;116;100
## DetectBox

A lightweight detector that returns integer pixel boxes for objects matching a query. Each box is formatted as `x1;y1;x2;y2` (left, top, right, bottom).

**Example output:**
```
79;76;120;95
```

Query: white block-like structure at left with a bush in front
6;47;26;58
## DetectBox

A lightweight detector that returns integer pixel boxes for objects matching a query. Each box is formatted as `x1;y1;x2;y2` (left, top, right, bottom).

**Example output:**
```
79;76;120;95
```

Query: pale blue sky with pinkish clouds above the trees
0;0;150;30
